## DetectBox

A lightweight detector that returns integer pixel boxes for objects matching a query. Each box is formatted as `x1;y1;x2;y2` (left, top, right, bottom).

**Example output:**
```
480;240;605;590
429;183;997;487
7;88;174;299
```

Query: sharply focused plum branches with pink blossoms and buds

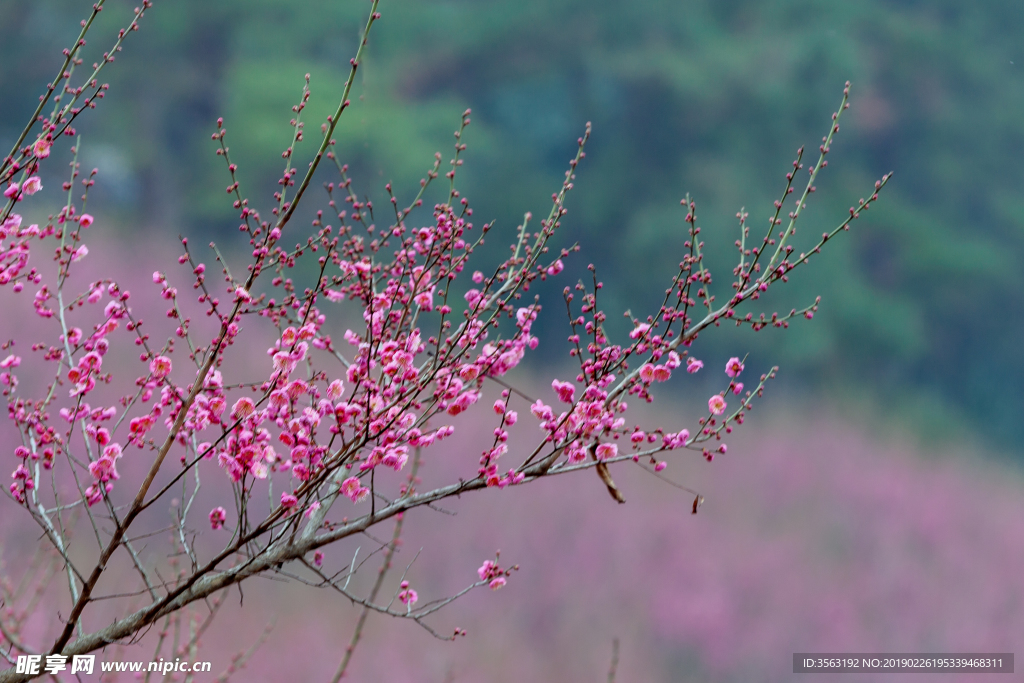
0;0;891;682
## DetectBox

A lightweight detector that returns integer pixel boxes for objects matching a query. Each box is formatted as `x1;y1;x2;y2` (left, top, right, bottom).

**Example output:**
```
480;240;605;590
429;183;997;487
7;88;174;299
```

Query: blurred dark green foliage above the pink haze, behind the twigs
0;0;1024;444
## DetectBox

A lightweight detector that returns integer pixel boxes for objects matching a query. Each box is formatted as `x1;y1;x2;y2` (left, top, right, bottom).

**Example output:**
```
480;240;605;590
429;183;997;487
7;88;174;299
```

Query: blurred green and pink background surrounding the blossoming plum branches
0;0;1024;681
